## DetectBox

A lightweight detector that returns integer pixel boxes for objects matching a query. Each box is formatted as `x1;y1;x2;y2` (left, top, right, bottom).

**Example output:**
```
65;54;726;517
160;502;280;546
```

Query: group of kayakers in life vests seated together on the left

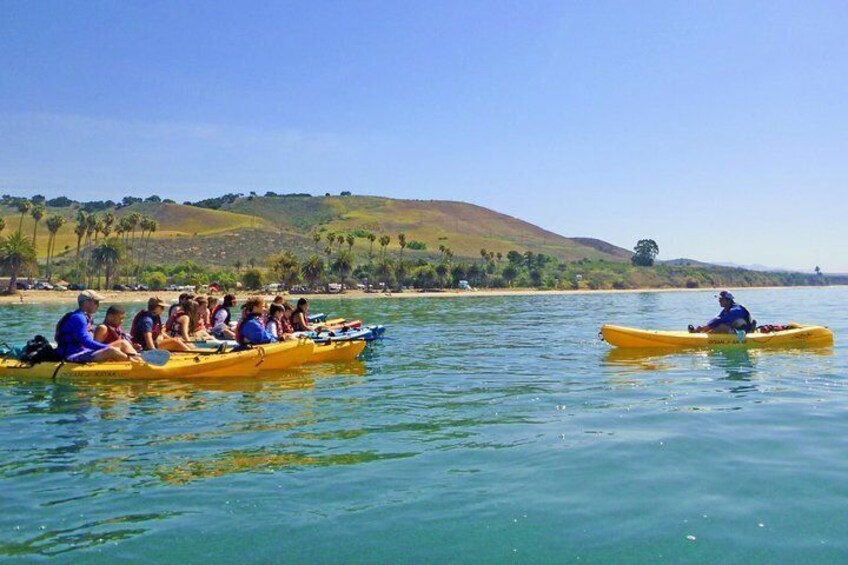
55;290;316;363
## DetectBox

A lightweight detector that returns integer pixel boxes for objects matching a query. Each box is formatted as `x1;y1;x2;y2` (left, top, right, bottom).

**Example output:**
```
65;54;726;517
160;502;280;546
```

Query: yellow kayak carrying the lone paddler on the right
601;324;833;349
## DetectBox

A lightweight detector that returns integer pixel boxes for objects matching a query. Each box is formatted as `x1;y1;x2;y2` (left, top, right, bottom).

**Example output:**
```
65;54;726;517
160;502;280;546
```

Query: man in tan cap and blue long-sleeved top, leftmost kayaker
56;290;136;363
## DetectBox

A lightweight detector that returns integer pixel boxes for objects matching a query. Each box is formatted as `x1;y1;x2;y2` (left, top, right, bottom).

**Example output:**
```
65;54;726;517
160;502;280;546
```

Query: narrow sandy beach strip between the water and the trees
0;285;843;305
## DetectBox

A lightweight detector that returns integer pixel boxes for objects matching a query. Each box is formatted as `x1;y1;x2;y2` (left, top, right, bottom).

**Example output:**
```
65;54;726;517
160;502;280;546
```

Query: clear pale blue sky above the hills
0;0;848;272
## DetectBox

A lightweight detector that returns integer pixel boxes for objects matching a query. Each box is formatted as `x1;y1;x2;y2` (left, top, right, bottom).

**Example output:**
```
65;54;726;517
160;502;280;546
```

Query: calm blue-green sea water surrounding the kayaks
0;288;848;563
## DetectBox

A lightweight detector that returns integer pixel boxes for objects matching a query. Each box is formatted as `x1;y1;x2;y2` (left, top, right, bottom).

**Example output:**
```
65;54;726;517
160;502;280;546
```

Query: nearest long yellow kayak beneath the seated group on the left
0;340;314;380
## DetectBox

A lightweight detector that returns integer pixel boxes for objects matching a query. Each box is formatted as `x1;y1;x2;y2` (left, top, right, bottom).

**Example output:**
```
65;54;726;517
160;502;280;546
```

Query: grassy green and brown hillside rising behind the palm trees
0;193;631;266
